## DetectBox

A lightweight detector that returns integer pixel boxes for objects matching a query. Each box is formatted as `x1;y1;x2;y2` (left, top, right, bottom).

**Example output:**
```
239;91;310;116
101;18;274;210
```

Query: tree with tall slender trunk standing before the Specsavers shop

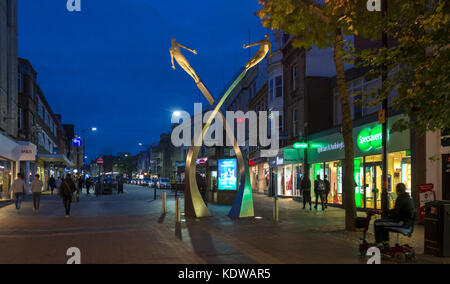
257;0;382;231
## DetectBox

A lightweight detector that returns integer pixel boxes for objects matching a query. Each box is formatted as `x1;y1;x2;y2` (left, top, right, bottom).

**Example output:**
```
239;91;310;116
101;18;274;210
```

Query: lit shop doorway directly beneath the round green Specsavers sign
365;162;383;209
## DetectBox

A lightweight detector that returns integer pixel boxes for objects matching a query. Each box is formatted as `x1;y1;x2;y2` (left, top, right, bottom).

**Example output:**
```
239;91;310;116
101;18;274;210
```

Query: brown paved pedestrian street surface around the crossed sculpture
0;185;444;264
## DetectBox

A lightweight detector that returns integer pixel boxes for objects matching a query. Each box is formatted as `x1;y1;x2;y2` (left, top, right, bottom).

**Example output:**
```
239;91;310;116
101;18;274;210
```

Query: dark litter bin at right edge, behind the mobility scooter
424;200;450;257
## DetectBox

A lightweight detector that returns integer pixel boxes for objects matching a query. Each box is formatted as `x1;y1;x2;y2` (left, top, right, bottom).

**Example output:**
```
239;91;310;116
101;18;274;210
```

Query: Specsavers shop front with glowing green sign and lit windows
308;116;411;209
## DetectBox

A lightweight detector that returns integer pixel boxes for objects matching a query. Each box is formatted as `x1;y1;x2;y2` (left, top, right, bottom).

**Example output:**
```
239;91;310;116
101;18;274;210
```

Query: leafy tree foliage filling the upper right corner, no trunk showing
355;0;450;134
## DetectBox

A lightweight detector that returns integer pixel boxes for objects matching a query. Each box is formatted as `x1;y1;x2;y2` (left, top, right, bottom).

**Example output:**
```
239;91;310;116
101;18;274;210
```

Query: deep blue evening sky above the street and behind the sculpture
18;0;267;158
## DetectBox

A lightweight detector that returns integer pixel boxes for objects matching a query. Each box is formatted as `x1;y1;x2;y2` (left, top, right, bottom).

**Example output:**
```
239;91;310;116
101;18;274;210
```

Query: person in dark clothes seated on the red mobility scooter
374;183;415;246
